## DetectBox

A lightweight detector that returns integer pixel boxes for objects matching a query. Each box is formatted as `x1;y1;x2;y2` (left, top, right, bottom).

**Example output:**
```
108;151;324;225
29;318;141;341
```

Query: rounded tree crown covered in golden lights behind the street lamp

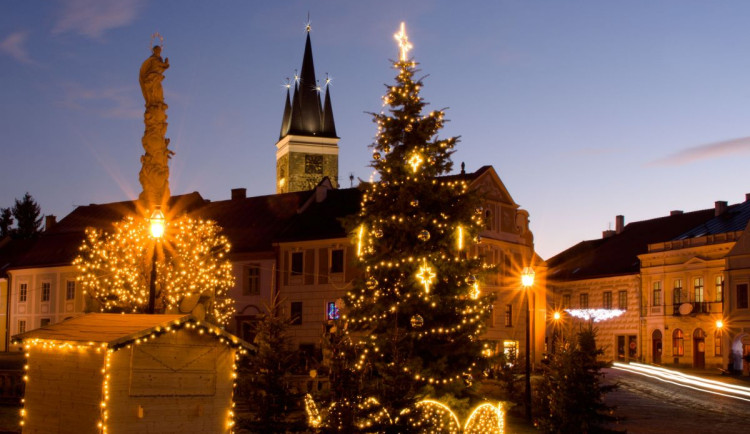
73;217;234;325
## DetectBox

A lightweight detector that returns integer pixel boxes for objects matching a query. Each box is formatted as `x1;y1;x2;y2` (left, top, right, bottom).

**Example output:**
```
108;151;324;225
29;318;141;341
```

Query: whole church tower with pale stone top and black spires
276;26;339;193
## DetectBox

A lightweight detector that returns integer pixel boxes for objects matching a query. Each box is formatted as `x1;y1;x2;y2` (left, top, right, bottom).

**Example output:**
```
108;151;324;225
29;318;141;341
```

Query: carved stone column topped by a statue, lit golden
138;41;174;213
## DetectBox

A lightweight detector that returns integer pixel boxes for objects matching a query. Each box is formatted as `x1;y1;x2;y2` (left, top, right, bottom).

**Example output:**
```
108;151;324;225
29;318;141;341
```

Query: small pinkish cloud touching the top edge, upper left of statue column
52;0;143;39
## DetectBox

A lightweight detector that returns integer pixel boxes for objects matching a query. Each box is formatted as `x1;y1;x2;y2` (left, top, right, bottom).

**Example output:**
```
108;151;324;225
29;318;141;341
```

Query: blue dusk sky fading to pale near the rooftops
0;0;750;259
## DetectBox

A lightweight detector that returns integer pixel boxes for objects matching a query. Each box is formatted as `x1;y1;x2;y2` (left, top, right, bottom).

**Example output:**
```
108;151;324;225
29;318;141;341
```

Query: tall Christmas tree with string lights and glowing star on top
346;24;492;415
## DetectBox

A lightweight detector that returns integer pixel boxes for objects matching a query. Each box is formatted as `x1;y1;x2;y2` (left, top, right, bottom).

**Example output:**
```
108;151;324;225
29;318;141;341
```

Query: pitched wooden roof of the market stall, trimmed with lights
13;313;253;349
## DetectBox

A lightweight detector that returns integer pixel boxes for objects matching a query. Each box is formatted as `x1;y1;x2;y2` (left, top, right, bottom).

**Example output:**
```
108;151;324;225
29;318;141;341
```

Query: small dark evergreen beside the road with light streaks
535;326;617;433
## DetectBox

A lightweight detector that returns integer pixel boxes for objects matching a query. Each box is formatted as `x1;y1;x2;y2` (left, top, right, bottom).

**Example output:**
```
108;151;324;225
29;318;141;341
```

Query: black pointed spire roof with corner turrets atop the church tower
280;28;336;138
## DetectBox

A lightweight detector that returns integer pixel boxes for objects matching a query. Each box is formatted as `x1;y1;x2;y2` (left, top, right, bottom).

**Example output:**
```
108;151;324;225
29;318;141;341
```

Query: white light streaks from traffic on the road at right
612;362;750;402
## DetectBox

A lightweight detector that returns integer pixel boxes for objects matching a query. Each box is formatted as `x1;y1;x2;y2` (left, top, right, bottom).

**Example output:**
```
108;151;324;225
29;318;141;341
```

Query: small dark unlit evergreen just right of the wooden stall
239;296;300;433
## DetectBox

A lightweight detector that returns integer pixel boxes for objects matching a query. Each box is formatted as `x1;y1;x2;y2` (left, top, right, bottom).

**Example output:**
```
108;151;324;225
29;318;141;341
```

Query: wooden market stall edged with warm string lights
14;313;251;433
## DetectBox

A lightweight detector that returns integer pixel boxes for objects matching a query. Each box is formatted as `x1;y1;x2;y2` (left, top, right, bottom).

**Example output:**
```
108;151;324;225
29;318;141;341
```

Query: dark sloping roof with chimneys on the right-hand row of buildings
547;208;714;282
